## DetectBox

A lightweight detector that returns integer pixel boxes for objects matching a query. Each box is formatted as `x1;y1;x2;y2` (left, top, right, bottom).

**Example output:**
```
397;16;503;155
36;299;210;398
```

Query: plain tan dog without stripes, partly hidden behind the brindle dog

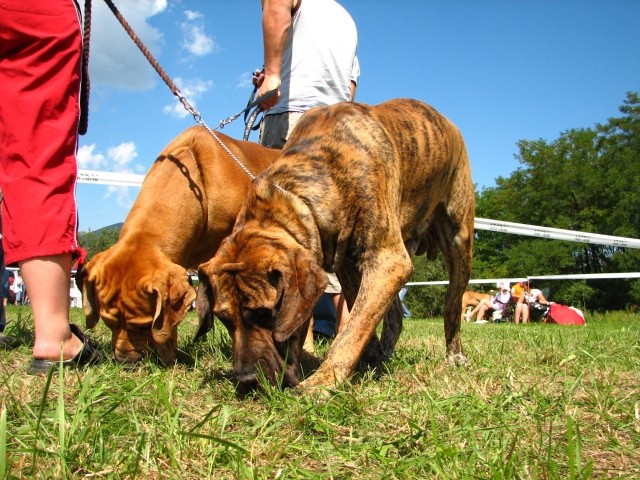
79;127;280;364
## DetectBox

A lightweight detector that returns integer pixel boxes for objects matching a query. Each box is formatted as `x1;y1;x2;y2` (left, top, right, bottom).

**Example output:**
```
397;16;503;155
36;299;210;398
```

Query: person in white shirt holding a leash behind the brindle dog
254;0;360;331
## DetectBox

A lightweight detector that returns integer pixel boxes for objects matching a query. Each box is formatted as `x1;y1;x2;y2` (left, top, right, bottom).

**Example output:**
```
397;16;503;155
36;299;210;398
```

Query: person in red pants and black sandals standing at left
0;0;101;374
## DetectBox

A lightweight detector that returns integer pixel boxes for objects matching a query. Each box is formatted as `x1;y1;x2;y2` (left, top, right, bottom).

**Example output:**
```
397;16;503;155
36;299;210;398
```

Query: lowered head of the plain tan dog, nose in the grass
78;249;196;365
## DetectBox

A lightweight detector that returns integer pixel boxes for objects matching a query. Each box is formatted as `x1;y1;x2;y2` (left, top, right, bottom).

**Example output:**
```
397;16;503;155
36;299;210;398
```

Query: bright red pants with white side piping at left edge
0;0;82;264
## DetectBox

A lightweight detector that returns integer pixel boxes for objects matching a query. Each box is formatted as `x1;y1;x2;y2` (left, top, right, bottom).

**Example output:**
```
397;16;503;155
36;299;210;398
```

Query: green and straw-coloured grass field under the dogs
0;307;640;479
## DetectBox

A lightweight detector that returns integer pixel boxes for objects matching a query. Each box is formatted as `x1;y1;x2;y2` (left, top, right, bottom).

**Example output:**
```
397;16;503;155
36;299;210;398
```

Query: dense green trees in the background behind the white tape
80;92;640;317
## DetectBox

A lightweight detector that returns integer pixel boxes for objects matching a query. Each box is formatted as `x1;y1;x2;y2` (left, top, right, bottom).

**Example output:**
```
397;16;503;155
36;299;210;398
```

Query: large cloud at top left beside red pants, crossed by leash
86;0;167;90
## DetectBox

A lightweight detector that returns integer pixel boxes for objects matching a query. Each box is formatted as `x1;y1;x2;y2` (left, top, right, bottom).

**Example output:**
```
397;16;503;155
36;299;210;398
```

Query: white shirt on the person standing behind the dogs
267;0;360;115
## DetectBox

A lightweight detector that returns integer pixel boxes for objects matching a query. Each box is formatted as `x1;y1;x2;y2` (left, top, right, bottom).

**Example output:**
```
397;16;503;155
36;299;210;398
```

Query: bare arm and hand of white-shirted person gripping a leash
258;0;298;110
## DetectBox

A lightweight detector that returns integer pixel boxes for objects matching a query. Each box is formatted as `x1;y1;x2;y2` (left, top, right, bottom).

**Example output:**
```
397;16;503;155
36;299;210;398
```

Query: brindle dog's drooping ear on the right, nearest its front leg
270;249;329;342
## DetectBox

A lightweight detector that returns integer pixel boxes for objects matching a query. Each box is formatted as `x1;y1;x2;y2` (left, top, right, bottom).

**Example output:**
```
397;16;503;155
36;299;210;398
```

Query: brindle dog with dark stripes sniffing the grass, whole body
198;100;475;391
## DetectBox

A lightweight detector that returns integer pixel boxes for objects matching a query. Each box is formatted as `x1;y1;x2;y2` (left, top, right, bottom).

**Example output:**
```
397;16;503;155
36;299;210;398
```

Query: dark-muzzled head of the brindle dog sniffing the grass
196;228;328;393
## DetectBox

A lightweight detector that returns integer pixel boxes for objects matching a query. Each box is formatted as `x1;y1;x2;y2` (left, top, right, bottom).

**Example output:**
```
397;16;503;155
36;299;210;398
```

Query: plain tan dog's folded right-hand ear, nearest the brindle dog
145;268;196;345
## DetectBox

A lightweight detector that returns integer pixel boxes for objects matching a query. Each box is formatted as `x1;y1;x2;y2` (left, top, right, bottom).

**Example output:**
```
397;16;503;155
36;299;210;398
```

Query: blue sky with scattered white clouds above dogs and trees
77;0;640;231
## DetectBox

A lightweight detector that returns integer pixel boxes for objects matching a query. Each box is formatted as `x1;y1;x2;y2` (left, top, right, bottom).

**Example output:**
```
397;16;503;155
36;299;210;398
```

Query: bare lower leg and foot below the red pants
20;254;83;360
